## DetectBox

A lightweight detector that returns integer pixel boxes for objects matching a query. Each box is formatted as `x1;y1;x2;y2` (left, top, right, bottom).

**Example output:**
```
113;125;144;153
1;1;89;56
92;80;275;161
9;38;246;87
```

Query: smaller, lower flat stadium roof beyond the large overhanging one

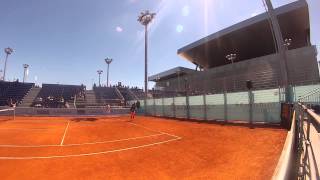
148;67;195;82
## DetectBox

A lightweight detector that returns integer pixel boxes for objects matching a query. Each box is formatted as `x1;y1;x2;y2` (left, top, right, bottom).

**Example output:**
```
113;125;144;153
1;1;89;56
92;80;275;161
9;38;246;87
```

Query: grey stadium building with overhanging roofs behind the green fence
149;1;319;94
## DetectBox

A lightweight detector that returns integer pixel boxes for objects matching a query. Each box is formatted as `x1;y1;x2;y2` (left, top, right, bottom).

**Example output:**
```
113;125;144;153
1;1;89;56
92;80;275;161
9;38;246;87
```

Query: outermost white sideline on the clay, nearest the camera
0;138;181;160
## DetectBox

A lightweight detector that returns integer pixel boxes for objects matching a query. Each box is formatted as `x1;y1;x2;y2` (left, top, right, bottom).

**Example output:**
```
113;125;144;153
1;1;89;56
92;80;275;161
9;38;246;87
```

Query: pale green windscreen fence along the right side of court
129;85;320;123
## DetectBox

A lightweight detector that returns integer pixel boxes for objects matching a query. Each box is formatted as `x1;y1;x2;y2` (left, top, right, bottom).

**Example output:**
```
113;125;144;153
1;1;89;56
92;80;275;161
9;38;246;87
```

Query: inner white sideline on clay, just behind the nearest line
0;133;166;148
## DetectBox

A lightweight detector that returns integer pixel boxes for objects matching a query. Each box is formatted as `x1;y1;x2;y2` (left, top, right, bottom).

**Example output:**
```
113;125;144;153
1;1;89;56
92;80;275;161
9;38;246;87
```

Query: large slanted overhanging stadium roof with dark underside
178;0;310;69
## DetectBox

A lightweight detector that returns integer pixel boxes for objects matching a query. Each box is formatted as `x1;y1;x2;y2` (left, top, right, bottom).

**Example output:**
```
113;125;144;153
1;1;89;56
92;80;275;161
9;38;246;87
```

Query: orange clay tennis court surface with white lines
0;116;286;180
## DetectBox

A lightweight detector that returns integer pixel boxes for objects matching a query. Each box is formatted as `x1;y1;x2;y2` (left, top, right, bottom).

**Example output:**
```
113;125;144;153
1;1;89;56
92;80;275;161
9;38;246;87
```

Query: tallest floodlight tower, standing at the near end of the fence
138;11;156;98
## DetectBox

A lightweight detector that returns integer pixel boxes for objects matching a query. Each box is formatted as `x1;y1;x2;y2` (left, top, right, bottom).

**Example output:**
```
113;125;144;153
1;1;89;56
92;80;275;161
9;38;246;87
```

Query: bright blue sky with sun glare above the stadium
0;0;320;87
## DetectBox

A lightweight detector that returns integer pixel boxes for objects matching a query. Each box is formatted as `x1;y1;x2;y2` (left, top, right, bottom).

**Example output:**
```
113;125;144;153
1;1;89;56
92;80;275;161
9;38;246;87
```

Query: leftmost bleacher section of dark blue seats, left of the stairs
0;81;34;106
